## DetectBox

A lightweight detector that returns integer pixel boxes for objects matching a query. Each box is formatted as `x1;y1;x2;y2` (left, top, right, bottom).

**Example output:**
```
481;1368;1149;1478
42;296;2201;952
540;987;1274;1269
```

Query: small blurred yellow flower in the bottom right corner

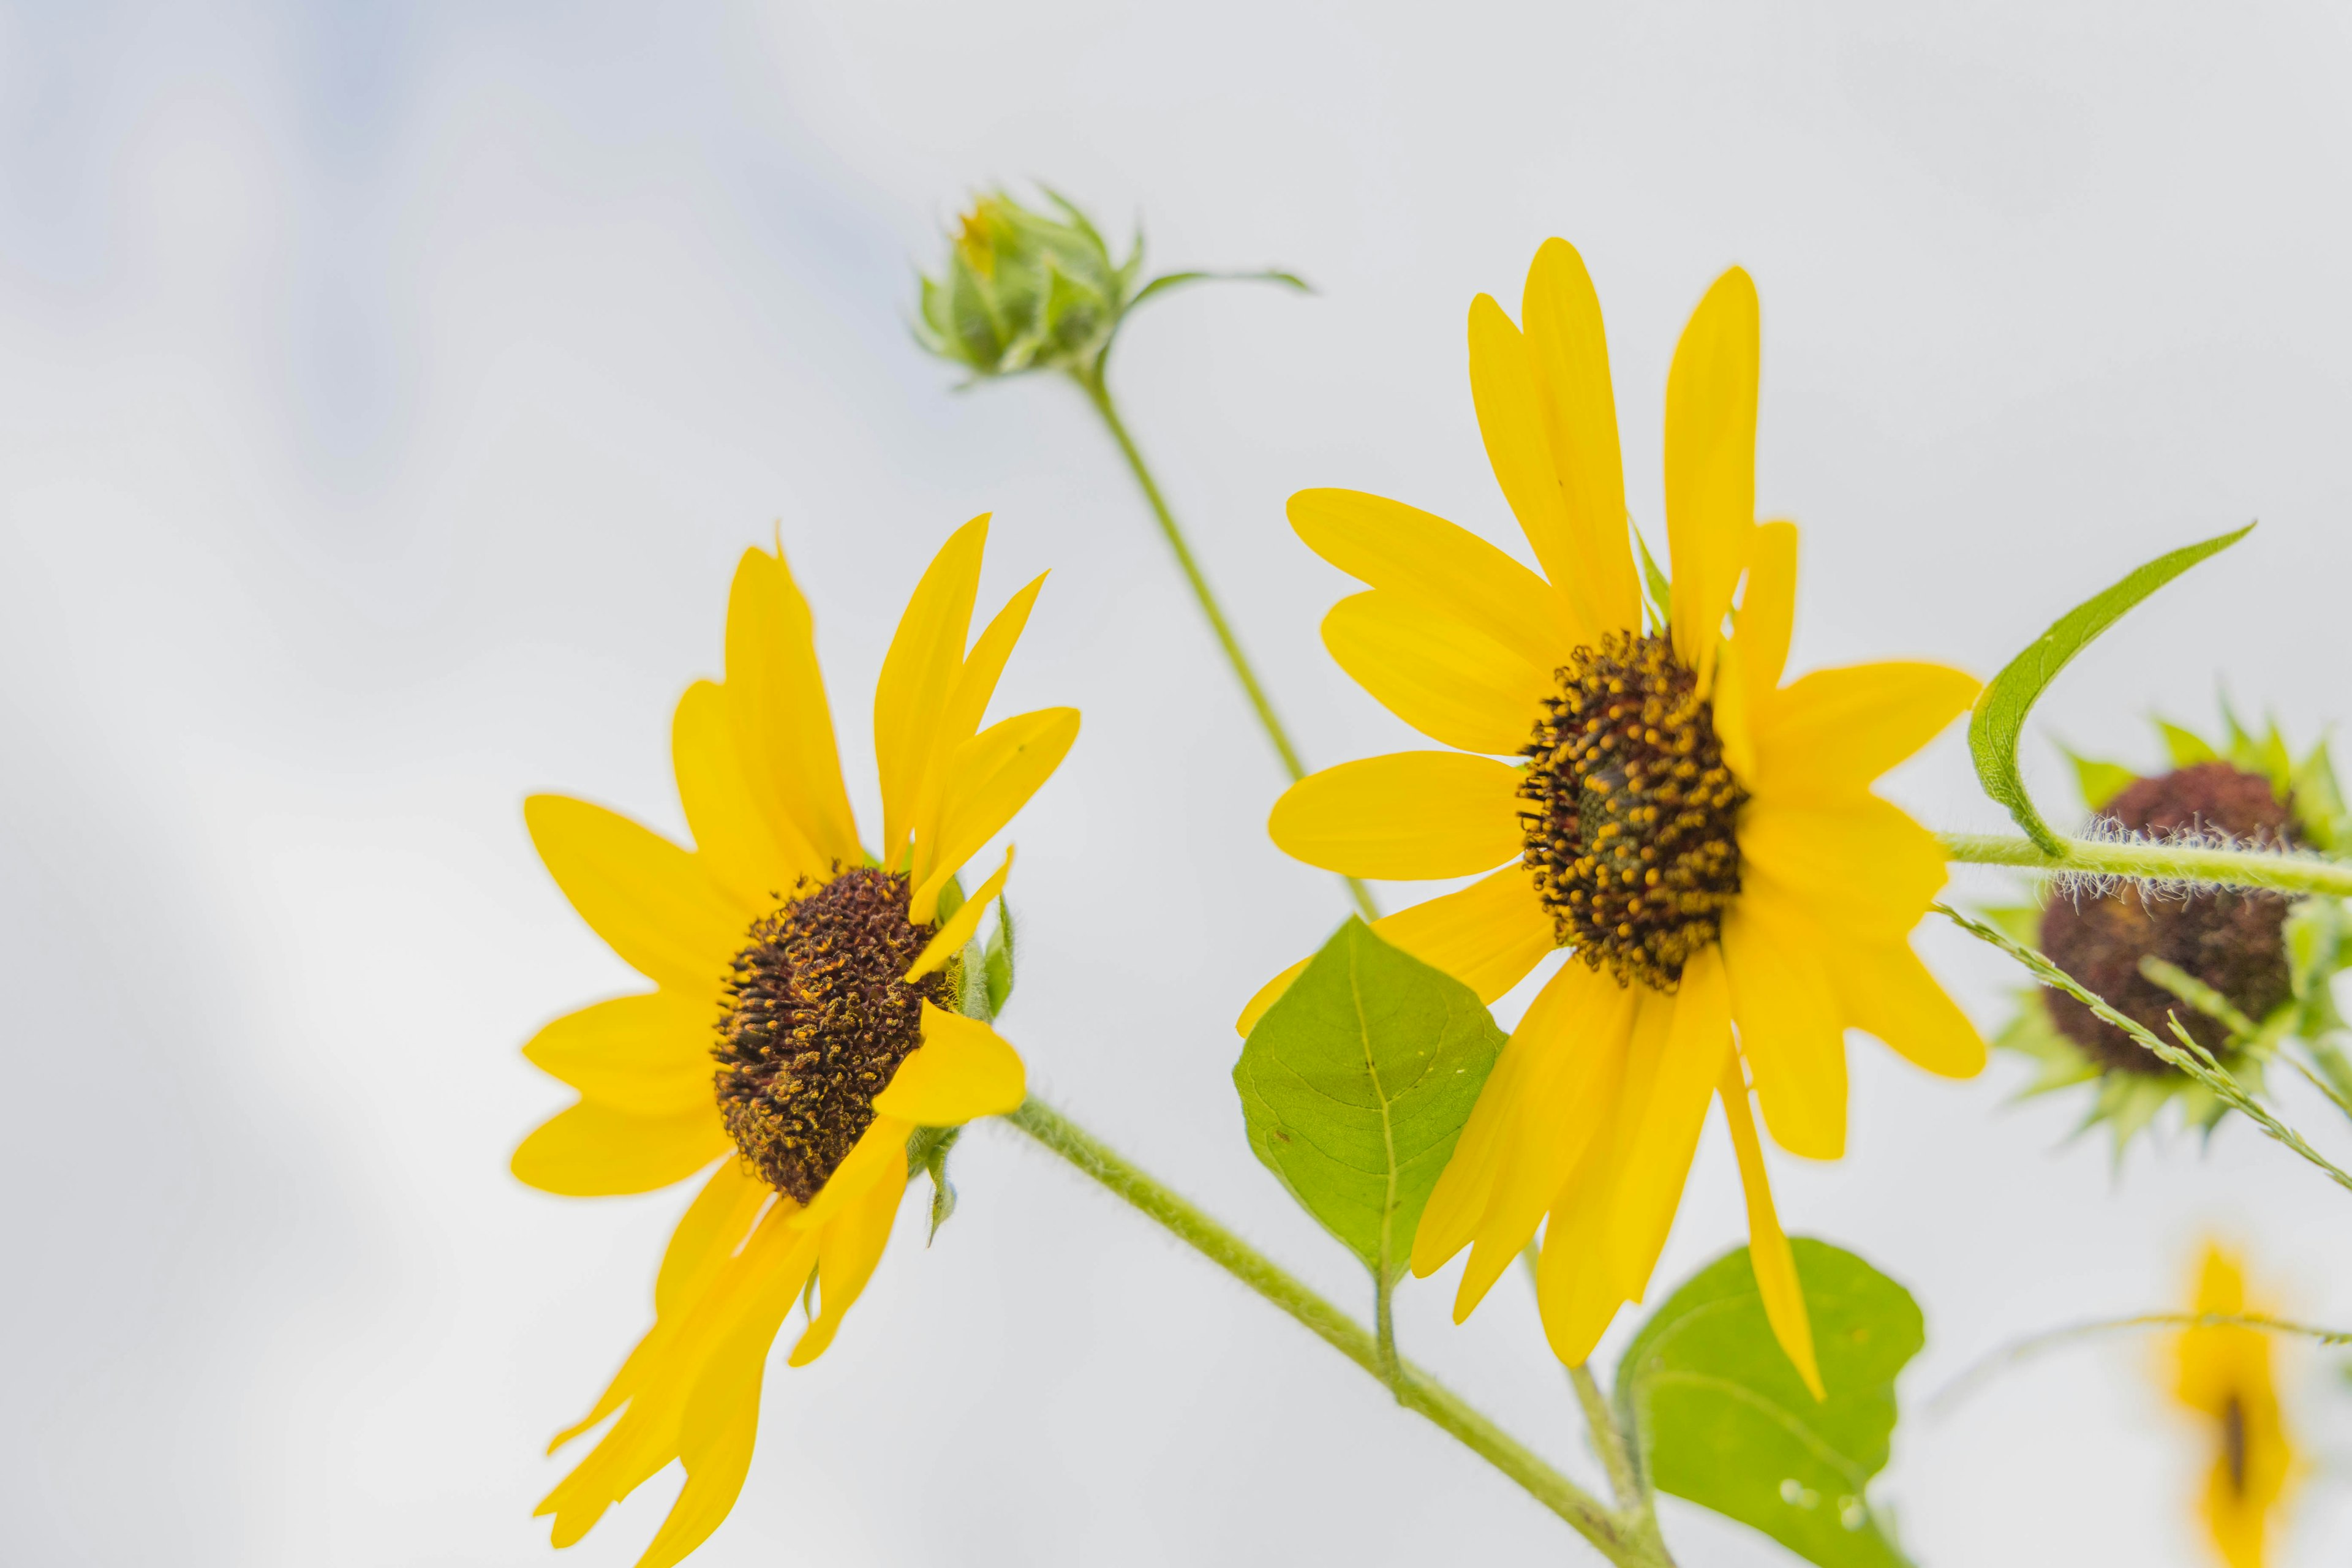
2173;1243;2296;1568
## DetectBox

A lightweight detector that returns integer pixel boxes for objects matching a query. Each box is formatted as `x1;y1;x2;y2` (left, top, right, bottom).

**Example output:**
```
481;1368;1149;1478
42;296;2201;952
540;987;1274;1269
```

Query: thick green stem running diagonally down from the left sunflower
1005;1096;1670;1568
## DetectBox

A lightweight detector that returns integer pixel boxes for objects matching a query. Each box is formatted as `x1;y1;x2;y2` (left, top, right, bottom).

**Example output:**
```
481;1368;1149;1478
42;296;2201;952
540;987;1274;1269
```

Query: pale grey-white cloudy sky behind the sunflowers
0;0;2352;1568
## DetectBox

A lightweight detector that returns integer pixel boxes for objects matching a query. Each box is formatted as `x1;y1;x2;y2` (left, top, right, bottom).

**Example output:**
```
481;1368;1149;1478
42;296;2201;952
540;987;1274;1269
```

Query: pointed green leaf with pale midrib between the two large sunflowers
1232;917;1503;1291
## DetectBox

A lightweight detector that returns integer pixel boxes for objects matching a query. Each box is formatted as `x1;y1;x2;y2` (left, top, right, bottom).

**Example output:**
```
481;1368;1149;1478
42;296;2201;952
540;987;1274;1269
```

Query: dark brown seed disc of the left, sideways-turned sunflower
710;867;950;1204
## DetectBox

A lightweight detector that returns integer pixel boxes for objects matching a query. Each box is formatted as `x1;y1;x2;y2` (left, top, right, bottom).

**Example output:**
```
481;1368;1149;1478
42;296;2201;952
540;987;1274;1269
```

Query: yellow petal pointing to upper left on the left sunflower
522;794;750;999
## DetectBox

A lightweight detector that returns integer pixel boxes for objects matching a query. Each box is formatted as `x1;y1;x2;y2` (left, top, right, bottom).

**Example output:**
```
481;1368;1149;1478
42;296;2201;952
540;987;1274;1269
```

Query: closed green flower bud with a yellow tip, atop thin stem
915;190;1143;376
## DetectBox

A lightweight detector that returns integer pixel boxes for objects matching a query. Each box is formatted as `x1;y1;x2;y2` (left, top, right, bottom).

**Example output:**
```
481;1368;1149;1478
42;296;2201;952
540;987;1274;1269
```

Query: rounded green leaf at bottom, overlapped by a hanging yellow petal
1616;1237;1926;1568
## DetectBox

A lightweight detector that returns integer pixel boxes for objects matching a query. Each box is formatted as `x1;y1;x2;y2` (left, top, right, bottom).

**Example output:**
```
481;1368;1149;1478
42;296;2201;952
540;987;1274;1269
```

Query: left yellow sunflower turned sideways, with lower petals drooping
515;517;1077;1568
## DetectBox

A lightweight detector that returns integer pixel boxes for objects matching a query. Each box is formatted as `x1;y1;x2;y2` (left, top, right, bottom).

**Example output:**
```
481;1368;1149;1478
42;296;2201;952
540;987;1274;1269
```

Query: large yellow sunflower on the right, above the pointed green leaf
1242;239;1985;1389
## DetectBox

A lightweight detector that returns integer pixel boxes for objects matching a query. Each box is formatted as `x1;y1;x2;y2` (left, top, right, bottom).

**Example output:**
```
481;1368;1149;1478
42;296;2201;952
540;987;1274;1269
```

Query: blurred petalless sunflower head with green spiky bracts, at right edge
1994;717;2343;1154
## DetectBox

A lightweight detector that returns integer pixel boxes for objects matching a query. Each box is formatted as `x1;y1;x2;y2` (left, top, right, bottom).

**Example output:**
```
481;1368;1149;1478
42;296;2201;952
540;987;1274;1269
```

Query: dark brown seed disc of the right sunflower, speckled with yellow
1520;632;1747;992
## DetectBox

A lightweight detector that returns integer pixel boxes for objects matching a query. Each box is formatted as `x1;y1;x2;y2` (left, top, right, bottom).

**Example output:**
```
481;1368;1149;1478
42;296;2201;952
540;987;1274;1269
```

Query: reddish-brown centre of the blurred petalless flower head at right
2041;762;2293;1077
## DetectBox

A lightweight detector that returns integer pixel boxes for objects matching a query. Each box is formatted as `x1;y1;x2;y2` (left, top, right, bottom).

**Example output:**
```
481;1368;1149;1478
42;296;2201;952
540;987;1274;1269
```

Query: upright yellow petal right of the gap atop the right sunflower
1665;268;1757;691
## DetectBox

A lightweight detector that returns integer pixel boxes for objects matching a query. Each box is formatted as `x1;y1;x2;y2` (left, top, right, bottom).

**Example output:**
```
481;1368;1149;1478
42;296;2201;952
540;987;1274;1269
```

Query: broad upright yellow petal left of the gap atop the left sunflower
722;550;865;865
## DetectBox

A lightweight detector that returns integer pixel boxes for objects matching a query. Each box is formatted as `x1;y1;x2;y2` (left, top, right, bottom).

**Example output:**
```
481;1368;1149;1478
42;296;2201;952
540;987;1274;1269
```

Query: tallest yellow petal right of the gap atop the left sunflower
875;515;988;870
